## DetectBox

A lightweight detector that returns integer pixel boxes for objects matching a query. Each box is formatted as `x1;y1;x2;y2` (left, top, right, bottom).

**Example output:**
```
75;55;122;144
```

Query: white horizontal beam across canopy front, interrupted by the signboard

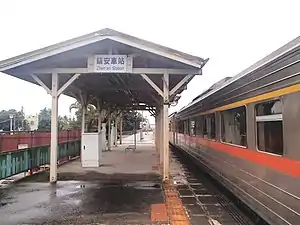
29;68;202;75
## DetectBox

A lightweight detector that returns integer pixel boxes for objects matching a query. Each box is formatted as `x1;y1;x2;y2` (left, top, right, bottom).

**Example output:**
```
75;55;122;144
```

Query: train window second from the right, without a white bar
221;106;247;146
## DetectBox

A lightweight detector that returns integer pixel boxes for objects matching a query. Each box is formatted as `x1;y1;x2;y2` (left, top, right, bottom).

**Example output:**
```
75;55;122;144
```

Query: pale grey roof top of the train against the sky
177;36;300;115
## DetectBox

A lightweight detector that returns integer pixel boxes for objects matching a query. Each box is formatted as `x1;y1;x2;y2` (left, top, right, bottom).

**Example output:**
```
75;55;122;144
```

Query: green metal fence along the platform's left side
0;140;80;179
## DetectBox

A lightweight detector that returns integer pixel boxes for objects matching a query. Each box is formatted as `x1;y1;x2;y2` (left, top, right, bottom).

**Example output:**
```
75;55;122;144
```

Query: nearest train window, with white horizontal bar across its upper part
255;100;283;155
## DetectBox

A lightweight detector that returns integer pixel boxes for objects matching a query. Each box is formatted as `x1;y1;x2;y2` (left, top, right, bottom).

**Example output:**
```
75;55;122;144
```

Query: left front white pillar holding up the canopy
50;73;59;183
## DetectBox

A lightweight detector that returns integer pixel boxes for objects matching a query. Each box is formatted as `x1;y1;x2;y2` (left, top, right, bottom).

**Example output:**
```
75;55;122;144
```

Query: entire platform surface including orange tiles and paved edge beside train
0;132;253;225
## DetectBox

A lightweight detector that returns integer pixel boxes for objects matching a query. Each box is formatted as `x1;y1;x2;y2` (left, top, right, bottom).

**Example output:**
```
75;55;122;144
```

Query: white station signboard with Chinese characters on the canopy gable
88;55;132;73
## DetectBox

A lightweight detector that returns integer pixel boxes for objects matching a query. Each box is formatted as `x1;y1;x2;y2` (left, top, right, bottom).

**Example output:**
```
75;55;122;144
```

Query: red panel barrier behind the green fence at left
0;130;81;152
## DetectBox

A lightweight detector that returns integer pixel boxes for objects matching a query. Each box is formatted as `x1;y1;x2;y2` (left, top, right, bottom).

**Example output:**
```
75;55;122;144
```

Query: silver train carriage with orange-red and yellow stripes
170;37;300;225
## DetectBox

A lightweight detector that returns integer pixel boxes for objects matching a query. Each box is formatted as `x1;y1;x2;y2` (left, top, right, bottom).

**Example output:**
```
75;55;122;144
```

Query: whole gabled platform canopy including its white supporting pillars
0;29;207;183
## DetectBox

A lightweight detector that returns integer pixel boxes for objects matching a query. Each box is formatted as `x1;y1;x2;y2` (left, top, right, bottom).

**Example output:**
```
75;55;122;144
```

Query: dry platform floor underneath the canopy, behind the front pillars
58;133;160;182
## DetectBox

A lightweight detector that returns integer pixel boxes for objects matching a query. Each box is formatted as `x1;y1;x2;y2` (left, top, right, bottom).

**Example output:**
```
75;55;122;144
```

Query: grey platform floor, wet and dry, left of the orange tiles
0;135;164;225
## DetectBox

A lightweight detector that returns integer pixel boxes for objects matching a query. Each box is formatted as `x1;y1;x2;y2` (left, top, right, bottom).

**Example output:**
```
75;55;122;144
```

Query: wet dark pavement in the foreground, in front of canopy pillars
0;181;163;225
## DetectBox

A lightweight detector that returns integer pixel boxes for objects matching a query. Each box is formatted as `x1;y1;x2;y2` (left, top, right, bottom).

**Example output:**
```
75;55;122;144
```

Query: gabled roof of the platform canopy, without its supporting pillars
0;29;207;111
